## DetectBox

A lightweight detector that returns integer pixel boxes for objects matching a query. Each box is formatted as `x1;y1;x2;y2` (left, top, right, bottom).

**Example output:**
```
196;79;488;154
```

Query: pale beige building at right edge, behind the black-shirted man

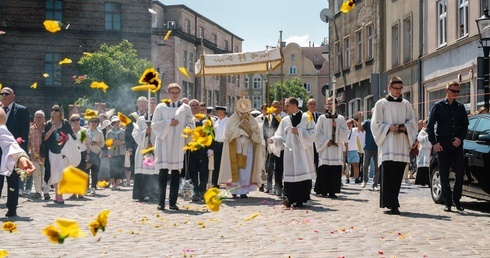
421;0;490;116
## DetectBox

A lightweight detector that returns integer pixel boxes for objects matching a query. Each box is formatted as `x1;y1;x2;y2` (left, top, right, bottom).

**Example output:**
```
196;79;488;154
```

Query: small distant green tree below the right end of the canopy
269;77;308;109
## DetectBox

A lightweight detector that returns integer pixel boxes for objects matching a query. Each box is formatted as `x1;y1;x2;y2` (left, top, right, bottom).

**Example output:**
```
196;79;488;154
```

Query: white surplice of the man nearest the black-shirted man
371;98;417;164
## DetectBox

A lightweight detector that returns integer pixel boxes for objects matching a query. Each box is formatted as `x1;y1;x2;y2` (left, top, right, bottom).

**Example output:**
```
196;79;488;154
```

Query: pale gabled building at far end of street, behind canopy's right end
264;43;329;112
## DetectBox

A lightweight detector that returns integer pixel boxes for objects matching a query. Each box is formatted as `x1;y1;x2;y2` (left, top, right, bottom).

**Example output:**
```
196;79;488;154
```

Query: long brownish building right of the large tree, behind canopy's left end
151;1;244;112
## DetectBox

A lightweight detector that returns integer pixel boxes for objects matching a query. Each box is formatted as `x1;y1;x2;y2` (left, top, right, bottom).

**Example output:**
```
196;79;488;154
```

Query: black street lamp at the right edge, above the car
475;8;490;109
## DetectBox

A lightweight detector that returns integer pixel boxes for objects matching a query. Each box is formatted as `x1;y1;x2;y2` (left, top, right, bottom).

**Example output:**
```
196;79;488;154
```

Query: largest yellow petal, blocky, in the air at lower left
58;166;88;194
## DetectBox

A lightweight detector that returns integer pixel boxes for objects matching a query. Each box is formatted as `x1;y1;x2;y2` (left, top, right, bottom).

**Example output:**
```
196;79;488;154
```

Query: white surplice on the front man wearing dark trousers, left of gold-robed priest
151;103;195;170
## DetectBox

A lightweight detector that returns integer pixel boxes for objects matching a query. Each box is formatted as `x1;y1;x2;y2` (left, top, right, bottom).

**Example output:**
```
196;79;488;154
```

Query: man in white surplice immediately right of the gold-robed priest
268;97;316;208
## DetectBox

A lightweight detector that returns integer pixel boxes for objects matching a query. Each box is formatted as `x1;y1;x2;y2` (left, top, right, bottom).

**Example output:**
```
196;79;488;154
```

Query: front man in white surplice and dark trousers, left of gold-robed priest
151;83;195;210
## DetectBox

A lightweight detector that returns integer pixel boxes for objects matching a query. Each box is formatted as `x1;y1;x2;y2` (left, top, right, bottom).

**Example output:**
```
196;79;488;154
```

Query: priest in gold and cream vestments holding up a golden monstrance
218;97;264;198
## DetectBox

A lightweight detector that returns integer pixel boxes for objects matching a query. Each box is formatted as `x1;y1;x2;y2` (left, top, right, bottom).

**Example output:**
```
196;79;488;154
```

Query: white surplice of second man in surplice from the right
315;115;349;166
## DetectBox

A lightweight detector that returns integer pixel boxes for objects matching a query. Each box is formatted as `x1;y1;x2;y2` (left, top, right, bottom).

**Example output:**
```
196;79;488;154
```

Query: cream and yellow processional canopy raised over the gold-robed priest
195;48;284;76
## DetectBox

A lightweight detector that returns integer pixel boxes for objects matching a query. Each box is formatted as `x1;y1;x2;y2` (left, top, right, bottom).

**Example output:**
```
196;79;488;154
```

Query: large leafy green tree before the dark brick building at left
77;40;153;113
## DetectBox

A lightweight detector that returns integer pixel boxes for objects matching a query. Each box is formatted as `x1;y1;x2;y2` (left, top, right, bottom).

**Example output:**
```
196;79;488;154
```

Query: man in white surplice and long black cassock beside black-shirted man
371;76;417;215
